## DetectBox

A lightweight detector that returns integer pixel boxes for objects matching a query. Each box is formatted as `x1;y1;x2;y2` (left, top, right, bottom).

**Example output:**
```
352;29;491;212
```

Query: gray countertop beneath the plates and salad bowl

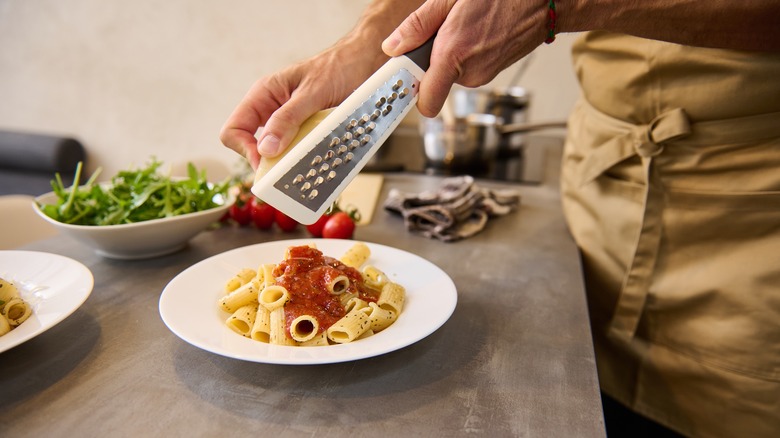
0;174;605;437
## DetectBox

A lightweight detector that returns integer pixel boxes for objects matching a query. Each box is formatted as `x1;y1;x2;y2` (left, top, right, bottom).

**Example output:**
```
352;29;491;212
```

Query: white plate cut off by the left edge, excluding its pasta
0;251;94;353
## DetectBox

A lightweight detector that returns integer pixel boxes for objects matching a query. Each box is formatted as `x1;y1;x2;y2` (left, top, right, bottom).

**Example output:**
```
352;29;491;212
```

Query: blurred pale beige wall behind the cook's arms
0;0;578;178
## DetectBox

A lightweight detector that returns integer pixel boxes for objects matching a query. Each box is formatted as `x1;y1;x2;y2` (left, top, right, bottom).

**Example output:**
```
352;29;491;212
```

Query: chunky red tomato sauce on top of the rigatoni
273;246;379;337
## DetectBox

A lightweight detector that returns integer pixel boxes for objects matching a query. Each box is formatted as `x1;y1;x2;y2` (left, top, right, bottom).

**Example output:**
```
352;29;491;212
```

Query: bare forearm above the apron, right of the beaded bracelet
556;0;780;51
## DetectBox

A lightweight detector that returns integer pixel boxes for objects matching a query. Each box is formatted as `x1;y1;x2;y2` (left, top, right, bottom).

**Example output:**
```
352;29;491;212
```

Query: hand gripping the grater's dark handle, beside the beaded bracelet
382;0;548;117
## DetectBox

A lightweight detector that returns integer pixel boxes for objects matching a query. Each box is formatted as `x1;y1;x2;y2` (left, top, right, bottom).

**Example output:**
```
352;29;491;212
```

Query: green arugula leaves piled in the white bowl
40;159;231;225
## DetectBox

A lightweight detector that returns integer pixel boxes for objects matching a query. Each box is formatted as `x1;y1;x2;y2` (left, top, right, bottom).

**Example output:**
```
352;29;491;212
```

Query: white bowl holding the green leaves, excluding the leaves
33;192;234;260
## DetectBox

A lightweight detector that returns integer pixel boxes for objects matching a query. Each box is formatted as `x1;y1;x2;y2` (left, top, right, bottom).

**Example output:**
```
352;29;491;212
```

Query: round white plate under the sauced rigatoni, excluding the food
160;239;457;365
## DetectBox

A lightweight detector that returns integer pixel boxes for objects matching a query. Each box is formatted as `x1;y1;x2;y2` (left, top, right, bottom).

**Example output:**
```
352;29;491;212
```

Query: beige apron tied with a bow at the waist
562;32;780;437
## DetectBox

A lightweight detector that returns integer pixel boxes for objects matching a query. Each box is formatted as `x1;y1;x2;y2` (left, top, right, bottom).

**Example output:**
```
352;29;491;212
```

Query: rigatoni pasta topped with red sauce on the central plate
217;242;406;346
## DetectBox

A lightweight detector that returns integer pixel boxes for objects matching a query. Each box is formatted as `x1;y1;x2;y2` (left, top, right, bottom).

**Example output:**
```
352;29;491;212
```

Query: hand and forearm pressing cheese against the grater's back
220;0;422;169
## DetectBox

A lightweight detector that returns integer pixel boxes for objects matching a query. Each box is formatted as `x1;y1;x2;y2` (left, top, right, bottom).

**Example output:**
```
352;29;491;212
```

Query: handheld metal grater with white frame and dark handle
252;38;433;225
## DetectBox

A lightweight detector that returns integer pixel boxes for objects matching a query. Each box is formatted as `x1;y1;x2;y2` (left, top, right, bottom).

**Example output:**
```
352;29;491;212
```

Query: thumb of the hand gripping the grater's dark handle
382;0;448;56
